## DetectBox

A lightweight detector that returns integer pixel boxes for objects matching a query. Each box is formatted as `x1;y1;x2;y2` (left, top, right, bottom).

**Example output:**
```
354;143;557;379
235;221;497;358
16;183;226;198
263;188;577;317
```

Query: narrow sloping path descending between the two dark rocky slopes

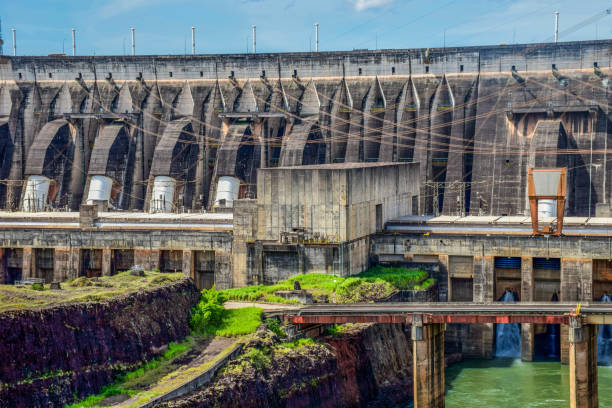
112;337;241;408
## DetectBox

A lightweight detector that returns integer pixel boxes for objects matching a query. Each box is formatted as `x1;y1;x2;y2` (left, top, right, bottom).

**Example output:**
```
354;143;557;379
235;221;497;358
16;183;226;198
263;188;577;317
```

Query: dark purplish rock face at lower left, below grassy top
0;280;200;408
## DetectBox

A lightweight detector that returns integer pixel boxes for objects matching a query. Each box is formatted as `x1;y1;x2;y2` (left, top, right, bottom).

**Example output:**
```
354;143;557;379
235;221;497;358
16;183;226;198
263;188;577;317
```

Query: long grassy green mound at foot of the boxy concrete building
222;266;434;303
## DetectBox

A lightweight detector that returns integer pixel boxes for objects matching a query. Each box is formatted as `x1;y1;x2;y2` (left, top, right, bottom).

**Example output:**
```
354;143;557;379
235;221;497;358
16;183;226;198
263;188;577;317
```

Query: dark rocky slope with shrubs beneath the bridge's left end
157;325;460;408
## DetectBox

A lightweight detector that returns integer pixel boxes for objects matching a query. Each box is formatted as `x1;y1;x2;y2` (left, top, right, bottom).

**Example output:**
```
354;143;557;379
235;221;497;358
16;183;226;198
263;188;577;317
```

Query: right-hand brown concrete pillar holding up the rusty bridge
569;316;599;408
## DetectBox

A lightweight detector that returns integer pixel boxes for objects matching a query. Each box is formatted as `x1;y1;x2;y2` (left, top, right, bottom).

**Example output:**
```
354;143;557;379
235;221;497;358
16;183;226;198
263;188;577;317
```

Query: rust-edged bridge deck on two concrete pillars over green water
285;302;612;408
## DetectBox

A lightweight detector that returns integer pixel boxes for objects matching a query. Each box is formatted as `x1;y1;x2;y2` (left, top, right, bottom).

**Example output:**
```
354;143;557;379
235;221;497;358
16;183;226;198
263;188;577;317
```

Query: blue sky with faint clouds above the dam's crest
0;0;612;55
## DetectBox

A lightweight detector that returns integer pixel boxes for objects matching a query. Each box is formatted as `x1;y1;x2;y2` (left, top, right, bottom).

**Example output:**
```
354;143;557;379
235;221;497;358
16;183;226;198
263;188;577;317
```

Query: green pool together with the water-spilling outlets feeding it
400;291;612;408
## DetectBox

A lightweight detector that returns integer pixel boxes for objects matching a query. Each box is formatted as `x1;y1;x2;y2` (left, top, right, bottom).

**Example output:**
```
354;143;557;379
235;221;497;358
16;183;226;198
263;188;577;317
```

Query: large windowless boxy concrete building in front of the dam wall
234;163;419;283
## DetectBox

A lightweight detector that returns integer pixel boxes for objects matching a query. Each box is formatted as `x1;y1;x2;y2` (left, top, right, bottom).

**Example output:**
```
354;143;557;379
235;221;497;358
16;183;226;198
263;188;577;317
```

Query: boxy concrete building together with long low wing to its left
0;163;419;288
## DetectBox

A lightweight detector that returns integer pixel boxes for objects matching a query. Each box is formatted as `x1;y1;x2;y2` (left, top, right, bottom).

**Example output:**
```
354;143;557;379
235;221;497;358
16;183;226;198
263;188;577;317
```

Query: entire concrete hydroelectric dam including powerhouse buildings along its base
0;40;612;407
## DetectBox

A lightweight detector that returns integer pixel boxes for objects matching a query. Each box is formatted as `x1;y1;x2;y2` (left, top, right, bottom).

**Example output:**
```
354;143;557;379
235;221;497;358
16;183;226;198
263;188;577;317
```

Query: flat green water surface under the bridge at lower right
446;359;612;408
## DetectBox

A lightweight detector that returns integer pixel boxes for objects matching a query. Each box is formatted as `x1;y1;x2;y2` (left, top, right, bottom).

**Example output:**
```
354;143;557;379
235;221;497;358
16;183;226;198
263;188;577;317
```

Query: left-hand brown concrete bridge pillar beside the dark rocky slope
412;315;445;408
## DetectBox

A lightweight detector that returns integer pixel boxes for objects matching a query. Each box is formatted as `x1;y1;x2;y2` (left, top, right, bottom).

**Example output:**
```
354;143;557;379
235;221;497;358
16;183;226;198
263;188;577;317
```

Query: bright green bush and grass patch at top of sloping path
189;286;263;337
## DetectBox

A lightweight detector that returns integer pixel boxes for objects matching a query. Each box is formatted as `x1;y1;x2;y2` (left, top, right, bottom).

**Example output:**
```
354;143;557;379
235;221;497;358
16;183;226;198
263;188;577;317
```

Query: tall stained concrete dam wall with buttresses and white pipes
0;40;612;216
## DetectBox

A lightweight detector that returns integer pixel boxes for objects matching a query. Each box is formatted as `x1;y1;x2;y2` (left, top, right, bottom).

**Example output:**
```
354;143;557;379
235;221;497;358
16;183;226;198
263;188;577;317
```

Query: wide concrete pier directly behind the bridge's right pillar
559;258;593;364
